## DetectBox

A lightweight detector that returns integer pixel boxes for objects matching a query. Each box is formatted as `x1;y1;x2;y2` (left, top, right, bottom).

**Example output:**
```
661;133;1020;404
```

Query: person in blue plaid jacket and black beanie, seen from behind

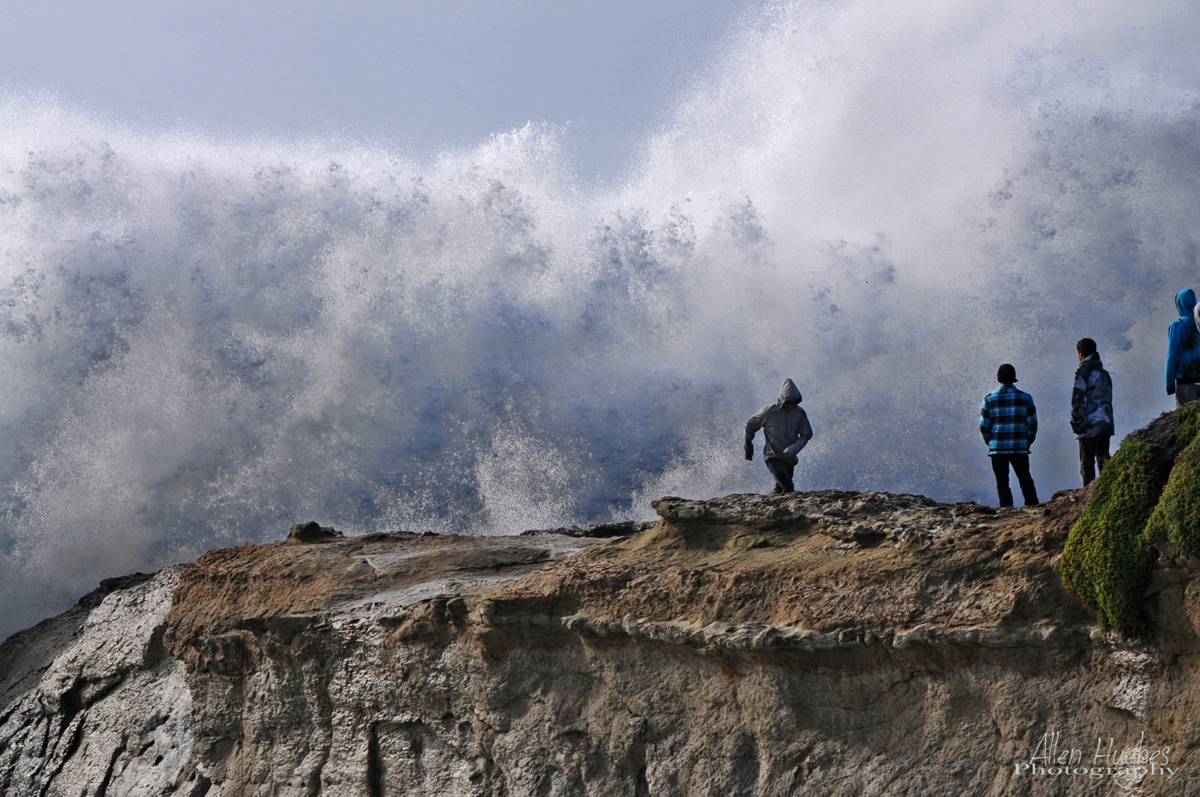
979;362;1038;507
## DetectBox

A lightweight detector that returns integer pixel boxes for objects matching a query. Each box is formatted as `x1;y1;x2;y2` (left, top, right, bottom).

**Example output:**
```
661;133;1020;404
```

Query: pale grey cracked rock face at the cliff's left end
0;567;192;797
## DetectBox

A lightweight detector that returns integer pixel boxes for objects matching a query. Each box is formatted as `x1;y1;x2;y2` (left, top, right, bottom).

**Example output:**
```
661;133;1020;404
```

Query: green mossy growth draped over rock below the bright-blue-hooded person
1062;405;1200;636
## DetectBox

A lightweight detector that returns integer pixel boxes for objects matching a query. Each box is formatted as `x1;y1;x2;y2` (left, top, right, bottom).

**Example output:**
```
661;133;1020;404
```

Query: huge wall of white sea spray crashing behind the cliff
0;1;1200;635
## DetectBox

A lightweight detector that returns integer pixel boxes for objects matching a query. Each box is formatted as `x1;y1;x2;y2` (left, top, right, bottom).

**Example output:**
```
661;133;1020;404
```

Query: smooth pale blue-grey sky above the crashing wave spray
0;0;751;178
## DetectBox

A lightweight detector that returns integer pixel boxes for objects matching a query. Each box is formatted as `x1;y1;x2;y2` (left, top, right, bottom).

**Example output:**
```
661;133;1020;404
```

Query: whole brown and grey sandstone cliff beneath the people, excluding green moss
0;491;1200;797
